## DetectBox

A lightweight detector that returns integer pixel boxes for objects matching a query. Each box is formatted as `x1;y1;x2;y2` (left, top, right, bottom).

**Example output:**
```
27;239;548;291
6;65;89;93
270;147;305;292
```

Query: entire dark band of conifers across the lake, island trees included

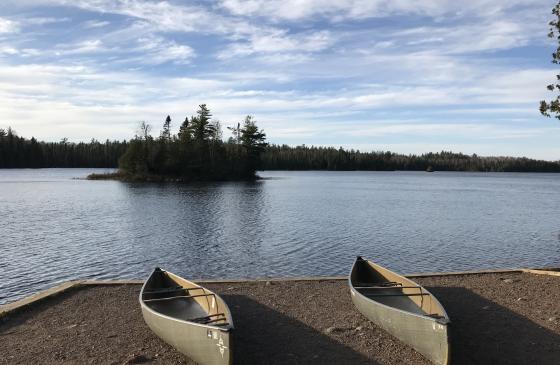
0;122;560;173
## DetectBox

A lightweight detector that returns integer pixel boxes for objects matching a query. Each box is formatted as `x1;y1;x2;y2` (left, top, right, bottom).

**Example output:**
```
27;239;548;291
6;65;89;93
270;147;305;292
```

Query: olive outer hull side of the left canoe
142;306;233;365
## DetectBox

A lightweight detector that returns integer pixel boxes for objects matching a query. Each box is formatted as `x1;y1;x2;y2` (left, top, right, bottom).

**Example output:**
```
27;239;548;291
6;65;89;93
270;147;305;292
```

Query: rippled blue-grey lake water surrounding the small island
0;169;560;303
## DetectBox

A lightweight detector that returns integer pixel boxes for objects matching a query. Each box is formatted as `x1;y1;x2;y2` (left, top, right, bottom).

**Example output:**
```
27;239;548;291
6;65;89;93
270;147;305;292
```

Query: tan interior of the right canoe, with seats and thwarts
350;257;449;321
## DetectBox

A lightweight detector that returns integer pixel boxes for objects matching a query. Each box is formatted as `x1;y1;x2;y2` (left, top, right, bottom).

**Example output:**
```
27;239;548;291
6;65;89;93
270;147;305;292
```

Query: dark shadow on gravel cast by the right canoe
427;287;560;364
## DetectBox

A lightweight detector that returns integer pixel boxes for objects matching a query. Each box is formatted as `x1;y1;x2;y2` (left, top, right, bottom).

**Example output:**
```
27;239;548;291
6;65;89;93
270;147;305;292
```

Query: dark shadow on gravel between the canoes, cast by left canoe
222;295;375;365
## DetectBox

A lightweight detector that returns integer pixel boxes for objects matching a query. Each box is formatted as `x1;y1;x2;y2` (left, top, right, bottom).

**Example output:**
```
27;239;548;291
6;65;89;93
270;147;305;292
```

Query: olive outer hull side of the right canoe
351;289;449;365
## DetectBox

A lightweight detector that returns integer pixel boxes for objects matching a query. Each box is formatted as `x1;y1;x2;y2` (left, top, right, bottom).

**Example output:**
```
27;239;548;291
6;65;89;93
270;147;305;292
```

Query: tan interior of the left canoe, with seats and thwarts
142;269;233;330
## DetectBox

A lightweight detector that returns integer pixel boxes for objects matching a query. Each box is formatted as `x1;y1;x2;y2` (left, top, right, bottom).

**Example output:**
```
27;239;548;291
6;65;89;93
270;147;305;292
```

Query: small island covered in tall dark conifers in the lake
88;104;267;181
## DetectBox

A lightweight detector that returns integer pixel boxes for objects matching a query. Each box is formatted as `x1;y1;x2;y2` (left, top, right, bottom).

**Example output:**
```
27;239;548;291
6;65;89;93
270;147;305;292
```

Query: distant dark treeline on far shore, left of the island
0;128;128;168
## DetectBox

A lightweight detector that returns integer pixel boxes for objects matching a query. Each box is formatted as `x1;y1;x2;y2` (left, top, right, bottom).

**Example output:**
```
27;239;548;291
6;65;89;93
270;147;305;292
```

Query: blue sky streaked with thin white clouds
0;0;560;160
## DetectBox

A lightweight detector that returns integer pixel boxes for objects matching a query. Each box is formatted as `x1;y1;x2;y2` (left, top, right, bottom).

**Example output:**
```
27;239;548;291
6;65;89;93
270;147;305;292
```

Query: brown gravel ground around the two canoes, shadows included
0;273;560;364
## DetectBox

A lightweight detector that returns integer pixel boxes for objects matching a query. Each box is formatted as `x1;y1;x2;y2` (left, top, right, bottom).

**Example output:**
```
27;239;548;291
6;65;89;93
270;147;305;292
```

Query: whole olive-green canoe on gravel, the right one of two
349;257;450;365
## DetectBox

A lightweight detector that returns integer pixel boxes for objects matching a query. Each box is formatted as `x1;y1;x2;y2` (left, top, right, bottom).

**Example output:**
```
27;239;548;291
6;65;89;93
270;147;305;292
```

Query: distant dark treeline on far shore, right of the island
261;145;560;172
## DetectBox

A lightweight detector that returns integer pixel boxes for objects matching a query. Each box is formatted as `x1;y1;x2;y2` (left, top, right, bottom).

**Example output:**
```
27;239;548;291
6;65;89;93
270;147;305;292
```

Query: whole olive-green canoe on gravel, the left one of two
140;268;233;365
